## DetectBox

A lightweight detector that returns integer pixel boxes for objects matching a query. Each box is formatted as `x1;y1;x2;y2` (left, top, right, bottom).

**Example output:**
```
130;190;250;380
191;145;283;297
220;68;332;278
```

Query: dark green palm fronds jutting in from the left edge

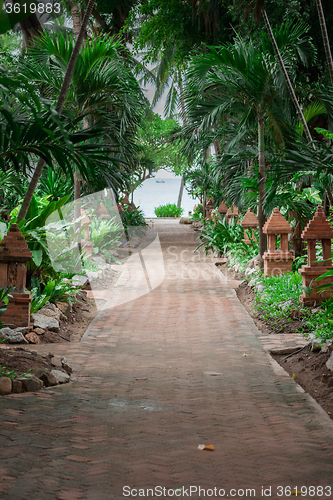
0;67;113;193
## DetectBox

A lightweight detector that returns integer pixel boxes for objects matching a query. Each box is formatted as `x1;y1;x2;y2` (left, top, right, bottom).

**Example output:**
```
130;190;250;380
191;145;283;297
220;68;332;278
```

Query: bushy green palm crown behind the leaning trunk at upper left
22;33;146;156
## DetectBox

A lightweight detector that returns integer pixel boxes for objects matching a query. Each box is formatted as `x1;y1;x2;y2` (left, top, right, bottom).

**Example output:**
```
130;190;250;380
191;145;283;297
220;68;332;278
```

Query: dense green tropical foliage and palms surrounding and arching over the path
0;0;333;340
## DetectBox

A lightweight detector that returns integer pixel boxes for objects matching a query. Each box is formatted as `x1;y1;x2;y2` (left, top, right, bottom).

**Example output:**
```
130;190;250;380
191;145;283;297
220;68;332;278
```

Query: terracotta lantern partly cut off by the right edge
299;205;333;304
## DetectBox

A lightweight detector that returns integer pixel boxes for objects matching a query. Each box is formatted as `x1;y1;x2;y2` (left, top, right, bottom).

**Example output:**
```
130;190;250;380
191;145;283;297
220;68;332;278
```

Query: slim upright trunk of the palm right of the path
258;117;267;269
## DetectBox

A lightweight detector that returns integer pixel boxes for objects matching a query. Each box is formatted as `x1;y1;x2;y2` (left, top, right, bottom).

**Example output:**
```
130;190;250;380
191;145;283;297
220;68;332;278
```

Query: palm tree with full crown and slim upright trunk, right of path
185;25;310;262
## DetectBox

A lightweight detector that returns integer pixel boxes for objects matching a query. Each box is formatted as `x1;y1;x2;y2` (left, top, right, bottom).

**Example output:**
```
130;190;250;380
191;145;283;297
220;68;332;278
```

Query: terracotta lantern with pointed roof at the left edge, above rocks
0;224;32;328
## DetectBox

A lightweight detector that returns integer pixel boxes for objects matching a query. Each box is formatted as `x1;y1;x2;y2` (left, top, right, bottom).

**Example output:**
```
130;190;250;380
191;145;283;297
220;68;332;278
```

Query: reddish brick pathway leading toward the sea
0;223;333;500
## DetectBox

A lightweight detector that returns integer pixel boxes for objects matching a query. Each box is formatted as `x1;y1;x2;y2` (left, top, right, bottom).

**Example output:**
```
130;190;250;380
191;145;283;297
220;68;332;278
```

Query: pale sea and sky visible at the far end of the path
134;171;199;217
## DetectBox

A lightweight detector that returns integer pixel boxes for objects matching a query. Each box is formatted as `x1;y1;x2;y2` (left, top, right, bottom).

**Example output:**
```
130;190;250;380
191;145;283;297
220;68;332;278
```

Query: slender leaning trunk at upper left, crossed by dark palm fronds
18;0;95;221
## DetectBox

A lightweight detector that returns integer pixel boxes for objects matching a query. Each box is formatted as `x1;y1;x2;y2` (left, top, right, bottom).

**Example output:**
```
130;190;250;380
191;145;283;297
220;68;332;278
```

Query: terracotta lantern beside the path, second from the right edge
263;208;294;276
